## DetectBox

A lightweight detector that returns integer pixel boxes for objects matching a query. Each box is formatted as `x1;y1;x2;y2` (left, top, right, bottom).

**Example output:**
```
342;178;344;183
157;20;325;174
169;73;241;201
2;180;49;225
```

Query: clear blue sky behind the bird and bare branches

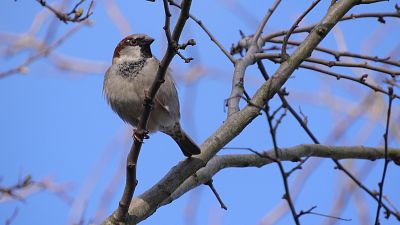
0;0;400;225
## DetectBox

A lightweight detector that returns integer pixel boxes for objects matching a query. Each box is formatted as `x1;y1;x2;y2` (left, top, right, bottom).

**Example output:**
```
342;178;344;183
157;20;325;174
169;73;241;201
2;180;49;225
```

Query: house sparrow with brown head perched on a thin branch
103;34;200;157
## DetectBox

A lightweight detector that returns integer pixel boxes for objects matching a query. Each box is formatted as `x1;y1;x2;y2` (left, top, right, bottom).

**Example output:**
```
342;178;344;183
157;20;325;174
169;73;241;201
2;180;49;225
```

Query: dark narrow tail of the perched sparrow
165;124;201;157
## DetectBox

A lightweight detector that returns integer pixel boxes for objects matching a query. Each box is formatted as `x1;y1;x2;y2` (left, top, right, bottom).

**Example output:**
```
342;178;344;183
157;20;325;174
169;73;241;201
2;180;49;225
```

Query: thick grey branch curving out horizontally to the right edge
162;144;400;207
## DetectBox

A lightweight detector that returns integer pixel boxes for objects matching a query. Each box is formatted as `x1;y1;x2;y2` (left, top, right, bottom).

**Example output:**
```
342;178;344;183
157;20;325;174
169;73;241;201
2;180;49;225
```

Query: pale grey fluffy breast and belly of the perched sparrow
103;59;180;131
